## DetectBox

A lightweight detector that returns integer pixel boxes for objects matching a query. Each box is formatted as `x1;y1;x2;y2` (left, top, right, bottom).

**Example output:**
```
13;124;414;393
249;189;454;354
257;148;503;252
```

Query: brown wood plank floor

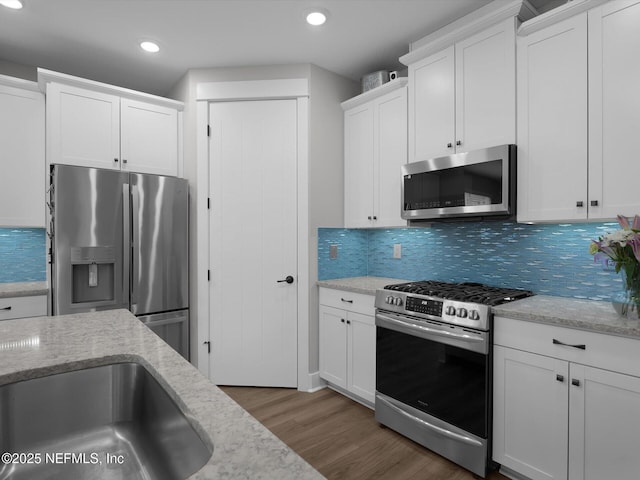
221;387;507;480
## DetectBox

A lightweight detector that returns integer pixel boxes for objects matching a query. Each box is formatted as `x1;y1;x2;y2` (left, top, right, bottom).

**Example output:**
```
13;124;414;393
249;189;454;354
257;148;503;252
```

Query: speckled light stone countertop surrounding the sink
0;310;324;480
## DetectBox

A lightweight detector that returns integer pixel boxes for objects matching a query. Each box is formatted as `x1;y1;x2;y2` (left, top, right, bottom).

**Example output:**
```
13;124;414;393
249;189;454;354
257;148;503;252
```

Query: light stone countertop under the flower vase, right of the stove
491;295;640;338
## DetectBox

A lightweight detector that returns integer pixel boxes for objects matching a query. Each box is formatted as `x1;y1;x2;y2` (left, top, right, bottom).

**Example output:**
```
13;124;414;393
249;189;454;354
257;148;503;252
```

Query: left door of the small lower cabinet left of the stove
319;305;347;388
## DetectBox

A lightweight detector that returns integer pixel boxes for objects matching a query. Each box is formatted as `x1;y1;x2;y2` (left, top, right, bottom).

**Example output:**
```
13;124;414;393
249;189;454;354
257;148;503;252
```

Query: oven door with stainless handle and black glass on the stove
376;311;491;439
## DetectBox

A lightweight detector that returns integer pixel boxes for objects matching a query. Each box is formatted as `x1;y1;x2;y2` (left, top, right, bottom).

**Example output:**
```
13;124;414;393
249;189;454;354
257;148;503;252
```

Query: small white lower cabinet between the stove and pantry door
320;288;376;406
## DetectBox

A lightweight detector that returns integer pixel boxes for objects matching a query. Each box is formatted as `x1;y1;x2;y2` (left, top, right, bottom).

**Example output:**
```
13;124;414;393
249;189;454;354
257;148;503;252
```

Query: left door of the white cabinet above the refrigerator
46;83;120;170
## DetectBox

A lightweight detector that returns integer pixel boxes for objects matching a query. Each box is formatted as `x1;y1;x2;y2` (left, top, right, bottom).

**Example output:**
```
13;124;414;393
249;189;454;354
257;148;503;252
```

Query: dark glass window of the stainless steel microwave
404;160;503;210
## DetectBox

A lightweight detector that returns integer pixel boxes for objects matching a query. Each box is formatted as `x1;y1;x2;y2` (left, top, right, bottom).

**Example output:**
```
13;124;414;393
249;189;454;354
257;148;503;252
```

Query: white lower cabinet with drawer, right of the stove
493;318;640;480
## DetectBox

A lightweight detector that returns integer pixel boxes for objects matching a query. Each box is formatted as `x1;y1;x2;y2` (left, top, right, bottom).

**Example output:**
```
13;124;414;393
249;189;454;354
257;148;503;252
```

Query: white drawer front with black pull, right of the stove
494;317;640;376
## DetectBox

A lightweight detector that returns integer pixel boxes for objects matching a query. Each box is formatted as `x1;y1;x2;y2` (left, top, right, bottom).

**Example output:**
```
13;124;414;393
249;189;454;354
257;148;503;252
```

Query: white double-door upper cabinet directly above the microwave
403;17;516;161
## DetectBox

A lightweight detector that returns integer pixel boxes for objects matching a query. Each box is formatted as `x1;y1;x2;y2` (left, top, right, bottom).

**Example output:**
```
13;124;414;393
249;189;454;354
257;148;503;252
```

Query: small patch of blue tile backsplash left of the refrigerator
0;228;47;283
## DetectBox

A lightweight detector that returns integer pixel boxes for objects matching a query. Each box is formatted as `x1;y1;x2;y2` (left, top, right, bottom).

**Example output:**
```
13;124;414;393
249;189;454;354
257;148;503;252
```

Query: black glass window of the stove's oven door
376;327;489;438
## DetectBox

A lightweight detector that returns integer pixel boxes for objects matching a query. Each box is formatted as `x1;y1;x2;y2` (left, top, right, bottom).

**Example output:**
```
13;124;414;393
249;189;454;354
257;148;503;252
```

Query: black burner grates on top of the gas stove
384;280;533;305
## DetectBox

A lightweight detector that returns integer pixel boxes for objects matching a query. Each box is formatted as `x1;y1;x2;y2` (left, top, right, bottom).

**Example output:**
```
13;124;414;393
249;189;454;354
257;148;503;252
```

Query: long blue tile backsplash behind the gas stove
318;222;622;301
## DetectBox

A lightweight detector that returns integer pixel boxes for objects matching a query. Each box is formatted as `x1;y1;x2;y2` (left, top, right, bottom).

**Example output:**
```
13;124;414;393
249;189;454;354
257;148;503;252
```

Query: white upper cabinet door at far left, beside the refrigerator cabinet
0;85;46;227
